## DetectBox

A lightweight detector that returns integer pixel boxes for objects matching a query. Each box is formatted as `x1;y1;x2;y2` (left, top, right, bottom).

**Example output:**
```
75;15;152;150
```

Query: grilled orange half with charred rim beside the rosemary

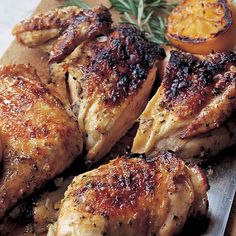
166;0;236;54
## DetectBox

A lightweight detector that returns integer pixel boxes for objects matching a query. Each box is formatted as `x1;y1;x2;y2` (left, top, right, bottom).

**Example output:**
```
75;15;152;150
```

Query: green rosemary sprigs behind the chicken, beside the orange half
63;0;177;44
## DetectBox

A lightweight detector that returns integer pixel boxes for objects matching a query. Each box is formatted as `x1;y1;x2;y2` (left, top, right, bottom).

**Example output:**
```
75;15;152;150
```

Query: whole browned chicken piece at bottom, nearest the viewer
48;153;208;236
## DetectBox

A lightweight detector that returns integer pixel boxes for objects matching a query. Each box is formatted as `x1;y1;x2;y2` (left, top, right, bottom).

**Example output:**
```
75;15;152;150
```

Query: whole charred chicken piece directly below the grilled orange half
132;49;236;159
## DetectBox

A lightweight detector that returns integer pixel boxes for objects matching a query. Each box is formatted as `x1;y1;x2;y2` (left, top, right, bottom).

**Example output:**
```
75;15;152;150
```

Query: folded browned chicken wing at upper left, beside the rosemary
13;6;112;63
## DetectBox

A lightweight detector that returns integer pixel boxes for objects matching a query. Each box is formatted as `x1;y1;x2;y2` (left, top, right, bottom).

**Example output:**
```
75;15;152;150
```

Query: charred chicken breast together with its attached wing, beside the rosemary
14;7;165;162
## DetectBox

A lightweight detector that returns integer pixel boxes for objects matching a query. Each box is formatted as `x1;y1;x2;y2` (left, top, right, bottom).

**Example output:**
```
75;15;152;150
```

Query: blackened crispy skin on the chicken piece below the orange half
161;50;236;138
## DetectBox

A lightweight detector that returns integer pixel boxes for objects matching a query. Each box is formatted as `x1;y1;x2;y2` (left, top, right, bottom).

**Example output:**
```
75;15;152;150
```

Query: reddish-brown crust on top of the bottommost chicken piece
73;152;209;218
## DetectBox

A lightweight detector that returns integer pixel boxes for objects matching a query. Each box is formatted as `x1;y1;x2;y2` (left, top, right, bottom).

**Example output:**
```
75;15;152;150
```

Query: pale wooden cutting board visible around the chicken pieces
0;0;236;236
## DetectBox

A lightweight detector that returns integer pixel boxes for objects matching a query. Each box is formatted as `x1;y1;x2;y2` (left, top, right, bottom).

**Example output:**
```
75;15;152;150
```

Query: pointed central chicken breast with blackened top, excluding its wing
59;25;165;162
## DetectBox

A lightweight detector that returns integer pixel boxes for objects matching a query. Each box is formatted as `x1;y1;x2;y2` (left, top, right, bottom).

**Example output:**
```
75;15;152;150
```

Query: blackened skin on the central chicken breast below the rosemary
69;25;165;106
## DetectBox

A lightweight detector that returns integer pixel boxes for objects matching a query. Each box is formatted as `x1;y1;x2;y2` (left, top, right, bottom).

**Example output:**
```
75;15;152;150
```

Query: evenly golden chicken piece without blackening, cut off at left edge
0;65;83;219
